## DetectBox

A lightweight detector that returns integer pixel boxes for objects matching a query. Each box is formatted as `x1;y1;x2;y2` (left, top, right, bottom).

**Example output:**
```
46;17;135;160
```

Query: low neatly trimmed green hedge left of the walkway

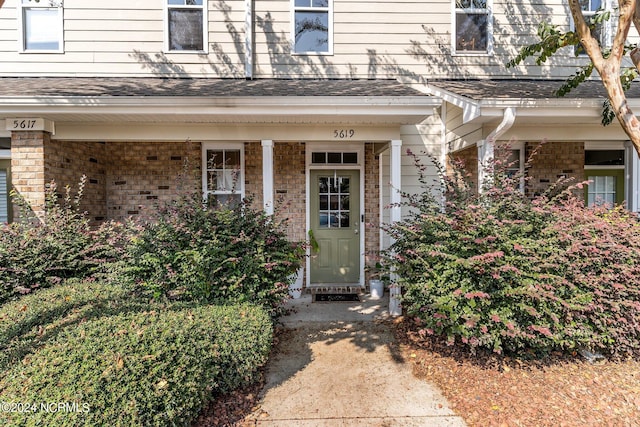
0;289;272;426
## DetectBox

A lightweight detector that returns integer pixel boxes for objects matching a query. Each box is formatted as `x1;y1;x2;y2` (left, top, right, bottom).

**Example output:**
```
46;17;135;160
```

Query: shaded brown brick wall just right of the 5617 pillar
44;140;107;223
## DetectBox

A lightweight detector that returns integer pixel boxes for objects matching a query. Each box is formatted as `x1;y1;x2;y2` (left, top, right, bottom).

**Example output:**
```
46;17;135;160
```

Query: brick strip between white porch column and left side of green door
273;142;307;240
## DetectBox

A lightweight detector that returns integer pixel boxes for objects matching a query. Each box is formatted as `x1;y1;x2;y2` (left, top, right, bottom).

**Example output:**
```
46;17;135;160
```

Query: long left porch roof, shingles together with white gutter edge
0;77;441;124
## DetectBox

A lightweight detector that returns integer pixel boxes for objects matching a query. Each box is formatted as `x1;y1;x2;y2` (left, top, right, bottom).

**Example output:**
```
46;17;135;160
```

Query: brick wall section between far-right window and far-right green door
525;142;584;197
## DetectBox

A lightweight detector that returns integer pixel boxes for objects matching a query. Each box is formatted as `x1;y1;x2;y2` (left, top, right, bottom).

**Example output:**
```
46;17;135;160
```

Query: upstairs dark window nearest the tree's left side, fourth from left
454;0;493;53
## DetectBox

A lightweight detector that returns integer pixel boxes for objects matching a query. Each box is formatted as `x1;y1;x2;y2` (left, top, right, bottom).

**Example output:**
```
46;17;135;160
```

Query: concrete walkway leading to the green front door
250;295;465;427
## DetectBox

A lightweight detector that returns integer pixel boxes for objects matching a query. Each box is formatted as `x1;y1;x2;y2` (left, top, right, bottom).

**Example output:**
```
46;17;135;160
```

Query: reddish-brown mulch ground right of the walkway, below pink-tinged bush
395;320;640;427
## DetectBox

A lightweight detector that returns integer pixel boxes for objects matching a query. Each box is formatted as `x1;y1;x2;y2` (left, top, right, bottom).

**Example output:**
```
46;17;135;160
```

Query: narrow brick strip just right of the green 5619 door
363;144;380;278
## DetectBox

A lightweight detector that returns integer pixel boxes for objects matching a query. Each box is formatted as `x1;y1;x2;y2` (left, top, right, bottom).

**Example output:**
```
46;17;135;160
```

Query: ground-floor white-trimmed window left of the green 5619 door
202;144;244;205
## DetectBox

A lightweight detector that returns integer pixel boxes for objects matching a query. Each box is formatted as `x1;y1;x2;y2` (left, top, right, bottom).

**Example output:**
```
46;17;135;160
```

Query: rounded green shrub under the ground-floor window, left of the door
128;195;303;314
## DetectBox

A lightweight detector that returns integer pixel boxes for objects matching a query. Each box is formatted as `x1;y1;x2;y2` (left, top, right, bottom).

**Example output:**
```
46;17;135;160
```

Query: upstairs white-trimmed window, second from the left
166;0;207;52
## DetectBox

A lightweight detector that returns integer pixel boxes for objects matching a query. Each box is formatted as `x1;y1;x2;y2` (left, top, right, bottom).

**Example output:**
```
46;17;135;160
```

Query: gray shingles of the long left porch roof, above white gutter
0;77;425;97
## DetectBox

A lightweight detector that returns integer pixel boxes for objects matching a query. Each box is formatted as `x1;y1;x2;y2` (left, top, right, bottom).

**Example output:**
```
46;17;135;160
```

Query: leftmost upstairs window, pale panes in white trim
18;0;64;52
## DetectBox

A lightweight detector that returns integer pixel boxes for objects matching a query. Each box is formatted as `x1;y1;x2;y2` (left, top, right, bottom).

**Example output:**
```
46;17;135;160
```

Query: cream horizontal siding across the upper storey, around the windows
0;0;636;78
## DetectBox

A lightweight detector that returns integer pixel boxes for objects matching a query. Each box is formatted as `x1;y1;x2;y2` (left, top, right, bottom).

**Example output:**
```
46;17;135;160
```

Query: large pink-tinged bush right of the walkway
386;147;640;356
